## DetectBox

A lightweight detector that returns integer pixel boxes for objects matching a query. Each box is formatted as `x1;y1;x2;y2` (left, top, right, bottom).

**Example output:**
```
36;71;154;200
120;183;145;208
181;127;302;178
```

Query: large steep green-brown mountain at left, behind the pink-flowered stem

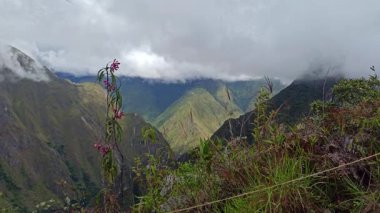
0;47;170;212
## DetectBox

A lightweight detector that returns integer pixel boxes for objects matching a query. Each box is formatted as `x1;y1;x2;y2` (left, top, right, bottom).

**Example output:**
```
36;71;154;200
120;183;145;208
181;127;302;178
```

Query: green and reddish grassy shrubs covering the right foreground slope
134;72;380;212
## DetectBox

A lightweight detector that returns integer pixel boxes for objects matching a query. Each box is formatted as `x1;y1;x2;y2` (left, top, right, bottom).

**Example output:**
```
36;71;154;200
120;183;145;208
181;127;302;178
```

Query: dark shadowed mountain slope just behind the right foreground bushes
211;77;340;143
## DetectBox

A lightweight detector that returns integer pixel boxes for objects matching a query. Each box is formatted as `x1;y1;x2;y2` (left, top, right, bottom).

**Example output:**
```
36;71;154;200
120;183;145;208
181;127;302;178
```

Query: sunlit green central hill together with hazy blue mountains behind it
57;72;284;153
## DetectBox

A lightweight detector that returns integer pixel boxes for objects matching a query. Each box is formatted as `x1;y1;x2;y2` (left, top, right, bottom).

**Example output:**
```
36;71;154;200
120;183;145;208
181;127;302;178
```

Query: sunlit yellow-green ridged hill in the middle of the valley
155;87;241;153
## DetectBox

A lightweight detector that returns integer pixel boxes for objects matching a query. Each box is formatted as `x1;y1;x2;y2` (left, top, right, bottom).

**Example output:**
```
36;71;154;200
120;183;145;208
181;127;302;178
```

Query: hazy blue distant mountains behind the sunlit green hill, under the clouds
57;72;284;122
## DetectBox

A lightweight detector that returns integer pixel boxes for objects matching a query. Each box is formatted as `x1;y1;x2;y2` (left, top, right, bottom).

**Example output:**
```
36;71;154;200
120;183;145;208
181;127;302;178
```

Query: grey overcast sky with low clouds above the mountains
0;0;380;81
